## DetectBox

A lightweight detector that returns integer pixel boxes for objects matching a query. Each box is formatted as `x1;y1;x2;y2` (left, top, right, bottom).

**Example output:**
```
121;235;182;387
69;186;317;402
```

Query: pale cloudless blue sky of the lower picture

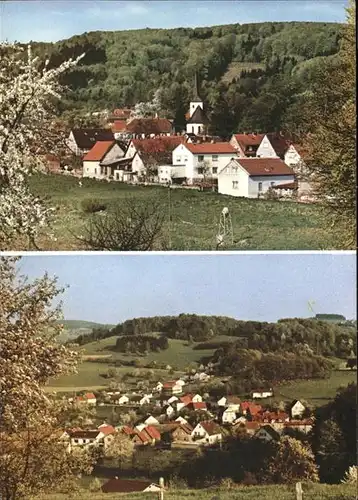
18;252;356;324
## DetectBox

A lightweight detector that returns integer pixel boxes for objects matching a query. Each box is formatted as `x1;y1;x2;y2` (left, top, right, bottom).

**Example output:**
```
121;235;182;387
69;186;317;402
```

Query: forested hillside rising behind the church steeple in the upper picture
34;22;342;134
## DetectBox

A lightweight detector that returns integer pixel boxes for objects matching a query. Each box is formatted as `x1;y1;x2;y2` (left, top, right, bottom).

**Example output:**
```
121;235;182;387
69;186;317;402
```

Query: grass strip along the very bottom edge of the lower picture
35;484;357;500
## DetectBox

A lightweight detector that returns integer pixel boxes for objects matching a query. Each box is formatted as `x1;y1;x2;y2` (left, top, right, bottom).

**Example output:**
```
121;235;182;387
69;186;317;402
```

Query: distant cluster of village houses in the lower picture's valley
60;367;314;493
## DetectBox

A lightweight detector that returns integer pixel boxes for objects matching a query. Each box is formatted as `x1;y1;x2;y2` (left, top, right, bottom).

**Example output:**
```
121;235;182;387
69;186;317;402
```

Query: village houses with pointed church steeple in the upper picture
46;79;314;202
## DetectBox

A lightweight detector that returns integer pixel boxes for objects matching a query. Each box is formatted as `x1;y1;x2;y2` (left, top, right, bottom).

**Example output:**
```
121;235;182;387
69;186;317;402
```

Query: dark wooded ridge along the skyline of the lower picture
72;314;356;358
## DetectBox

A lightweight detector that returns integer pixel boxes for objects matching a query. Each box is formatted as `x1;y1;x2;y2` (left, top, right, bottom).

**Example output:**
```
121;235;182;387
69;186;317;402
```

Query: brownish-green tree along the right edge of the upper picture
304;0;356;248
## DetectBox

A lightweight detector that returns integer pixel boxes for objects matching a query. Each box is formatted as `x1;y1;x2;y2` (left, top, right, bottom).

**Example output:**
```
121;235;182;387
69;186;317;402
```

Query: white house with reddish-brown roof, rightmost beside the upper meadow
218;158;295;198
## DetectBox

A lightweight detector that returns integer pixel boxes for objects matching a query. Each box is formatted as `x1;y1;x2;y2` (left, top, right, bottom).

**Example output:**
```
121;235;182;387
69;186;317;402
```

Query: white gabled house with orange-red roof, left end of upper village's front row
82;141;124;179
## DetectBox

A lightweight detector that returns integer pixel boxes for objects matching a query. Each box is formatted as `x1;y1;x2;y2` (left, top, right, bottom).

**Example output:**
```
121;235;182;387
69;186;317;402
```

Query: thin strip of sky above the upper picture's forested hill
0;0;347;42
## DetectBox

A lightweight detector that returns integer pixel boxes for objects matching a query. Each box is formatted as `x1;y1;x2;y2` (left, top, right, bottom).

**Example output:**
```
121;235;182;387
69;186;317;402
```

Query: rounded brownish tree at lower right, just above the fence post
263;436;318;484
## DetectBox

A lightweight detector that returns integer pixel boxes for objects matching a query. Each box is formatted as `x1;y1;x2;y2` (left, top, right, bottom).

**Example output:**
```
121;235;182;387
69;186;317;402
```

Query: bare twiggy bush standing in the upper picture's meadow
78;195;165;251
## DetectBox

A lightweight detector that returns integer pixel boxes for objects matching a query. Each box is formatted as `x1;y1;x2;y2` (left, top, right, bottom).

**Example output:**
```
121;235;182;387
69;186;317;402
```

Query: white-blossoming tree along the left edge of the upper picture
0;43;82;248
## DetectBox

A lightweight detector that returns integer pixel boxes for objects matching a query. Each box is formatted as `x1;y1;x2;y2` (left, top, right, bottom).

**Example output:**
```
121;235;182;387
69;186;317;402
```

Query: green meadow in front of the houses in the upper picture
19;175;335;250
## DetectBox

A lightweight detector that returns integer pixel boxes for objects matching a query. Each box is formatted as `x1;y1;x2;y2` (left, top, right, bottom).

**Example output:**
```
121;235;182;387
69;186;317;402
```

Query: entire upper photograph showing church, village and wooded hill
0;0;356;252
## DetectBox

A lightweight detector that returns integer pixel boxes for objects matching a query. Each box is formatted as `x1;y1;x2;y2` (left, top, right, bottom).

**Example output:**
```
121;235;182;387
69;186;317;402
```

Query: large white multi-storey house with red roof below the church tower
172;142;236;184
